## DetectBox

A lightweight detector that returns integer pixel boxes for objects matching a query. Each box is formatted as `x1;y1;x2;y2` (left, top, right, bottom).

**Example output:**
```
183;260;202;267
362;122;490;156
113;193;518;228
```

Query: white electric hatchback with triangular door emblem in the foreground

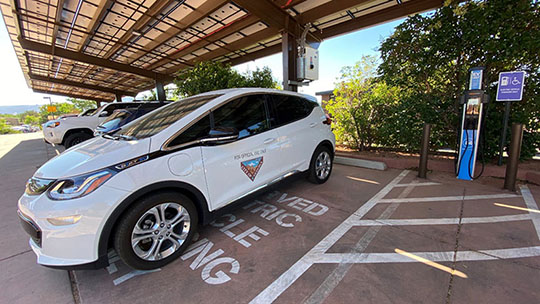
18;89;335;269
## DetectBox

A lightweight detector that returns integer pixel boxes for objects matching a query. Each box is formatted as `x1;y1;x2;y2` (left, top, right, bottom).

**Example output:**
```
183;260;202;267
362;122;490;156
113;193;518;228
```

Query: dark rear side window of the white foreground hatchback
271;95;317;126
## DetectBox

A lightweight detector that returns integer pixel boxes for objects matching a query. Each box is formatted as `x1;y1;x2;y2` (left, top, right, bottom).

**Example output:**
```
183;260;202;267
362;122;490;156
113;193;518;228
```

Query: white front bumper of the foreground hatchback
18;185;128;268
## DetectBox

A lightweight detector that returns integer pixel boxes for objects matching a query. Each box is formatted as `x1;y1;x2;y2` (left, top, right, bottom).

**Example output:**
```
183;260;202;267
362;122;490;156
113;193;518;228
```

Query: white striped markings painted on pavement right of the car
250;170;540;303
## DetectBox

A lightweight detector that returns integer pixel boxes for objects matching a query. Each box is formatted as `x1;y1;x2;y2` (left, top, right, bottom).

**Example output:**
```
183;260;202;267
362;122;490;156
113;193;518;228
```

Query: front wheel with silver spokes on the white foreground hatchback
114;192;198;270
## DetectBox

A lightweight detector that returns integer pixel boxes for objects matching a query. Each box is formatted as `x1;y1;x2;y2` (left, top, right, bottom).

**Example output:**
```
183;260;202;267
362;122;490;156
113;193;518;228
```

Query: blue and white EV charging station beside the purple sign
456;67;489;180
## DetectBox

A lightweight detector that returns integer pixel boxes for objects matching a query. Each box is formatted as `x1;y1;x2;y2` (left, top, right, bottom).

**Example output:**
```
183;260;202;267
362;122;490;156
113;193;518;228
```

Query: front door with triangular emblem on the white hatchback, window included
202;95;281;209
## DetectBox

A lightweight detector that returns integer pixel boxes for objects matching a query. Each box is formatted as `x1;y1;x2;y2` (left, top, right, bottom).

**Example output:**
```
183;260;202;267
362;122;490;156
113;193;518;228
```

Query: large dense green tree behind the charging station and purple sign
379;0;540;158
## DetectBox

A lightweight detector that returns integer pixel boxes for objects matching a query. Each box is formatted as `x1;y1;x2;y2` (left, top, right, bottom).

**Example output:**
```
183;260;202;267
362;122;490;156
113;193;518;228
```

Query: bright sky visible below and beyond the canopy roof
0;14;403;106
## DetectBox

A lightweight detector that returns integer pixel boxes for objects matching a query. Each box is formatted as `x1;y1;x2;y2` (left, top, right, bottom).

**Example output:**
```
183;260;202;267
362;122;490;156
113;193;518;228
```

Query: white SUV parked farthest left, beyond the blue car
43;102;165;149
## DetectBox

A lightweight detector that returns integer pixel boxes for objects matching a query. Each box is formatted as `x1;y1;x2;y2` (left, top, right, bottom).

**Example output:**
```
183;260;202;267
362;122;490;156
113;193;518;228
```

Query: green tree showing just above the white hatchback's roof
175;61;277;96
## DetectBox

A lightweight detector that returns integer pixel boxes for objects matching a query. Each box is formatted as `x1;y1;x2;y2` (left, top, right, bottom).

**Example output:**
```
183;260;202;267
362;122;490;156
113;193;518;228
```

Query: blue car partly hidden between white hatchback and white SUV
94;103;166;136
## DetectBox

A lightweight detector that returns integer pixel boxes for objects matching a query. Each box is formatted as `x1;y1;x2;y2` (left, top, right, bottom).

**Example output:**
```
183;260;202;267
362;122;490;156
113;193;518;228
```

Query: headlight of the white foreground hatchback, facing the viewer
47;169;116;200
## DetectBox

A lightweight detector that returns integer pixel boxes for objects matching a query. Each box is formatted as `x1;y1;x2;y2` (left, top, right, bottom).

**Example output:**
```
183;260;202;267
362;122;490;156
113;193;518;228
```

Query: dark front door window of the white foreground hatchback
212;95;269;138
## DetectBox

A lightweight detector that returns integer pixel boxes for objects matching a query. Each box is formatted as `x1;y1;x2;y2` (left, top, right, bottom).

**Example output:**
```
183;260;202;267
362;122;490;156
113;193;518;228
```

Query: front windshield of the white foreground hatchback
115;95;221;139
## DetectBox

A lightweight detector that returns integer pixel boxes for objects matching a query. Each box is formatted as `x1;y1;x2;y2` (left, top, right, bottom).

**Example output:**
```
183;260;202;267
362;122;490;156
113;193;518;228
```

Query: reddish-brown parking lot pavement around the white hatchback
0;135;540;303
